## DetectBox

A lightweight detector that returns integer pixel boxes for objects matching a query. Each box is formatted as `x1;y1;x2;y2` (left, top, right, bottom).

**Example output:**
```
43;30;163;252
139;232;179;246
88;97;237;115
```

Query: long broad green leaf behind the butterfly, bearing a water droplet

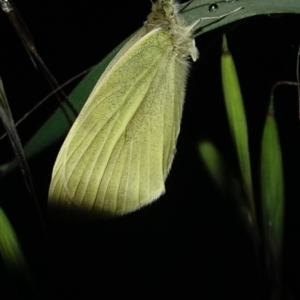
0;0;300;174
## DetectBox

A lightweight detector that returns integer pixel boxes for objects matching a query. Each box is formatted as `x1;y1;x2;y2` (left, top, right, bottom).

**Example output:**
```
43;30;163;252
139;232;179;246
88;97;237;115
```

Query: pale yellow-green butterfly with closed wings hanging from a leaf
49;0;241;216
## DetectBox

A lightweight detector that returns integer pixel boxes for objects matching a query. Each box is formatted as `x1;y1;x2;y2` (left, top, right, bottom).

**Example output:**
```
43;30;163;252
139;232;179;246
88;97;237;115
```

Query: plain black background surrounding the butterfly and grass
0;0;300;299
